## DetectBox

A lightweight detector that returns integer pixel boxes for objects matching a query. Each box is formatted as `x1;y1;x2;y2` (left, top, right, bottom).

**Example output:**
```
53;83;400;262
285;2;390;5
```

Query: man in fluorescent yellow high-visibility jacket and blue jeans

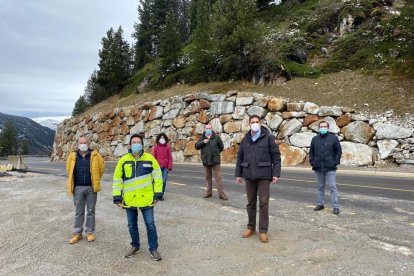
112;134;162;261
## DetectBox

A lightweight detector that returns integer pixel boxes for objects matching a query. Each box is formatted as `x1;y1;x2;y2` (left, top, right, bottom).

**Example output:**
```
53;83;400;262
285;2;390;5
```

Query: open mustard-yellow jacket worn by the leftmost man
66;150;105;195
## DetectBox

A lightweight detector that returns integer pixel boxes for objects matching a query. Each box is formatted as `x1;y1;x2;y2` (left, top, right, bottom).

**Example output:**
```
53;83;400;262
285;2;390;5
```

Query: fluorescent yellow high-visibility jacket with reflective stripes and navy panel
112;152;162;208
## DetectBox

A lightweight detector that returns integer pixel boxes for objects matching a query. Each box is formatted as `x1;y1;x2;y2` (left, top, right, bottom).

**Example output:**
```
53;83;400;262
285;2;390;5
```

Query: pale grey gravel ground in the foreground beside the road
0;173;414;275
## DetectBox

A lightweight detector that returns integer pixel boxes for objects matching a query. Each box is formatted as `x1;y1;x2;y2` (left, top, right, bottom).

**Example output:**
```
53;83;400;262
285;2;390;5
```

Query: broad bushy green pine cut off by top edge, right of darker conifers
211;0;260;79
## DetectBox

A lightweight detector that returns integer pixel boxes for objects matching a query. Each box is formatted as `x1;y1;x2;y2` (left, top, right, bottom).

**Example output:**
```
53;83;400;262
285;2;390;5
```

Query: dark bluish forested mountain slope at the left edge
0;112;55;154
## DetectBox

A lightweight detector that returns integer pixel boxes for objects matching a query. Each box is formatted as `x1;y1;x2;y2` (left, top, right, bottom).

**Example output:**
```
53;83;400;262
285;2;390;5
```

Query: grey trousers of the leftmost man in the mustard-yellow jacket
73;186;98;235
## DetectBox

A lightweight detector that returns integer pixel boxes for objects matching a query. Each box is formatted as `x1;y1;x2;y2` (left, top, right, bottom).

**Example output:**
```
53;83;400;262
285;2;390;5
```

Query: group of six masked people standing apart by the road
66;115;342;261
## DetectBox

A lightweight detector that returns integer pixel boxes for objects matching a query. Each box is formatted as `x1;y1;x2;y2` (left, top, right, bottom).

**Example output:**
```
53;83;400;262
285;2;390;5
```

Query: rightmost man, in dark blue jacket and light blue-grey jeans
309;121;342;215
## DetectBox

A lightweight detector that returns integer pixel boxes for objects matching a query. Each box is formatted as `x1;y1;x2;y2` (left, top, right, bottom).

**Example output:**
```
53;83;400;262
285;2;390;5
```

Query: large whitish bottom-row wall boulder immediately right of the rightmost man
341;142;374;166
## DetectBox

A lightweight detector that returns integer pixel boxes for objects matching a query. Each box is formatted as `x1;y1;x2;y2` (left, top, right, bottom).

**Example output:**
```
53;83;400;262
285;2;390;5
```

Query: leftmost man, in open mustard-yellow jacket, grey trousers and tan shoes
66;136;105;244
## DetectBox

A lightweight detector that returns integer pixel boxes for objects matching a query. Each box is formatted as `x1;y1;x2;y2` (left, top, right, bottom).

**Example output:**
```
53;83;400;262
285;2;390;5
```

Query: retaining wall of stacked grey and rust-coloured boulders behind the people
52;91;414;166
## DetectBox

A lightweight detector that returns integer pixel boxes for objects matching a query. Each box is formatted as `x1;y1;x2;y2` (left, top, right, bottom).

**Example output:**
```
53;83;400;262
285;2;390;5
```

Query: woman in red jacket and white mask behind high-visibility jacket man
152;133;173;200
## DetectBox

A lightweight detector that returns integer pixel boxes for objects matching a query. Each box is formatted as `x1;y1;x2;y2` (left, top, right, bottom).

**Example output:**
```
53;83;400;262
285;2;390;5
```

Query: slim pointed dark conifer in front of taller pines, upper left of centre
159;7;181;73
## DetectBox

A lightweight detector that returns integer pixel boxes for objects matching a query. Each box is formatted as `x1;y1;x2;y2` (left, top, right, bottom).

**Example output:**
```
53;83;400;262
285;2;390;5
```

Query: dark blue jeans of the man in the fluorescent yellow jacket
126;207;158;251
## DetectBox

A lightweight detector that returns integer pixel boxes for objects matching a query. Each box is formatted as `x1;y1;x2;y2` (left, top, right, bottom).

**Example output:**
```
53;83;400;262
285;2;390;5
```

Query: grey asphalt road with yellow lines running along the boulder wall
25;158;414;216
